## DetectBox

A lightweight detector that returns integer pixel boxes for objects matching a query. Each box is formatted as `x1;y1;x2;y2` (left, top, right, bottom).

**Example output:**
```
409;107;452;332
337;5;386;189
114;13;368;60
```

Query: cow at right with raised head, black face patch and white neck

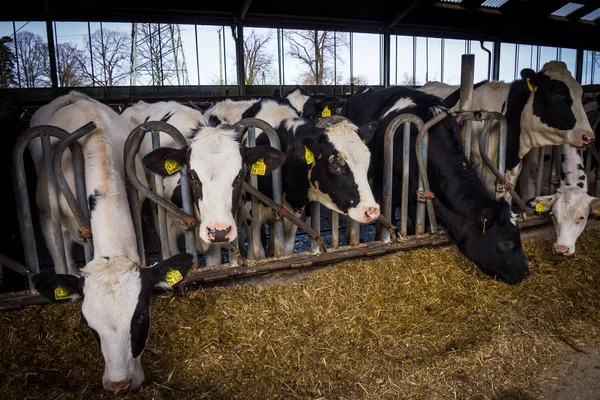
419;61;594;200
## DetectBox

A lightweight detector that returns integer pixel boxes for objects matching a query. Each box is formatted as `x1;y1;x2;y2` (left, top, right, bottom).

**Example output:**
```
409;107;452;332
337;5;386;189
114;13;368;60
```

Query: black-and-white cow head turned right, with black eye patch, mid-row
302;121;379;223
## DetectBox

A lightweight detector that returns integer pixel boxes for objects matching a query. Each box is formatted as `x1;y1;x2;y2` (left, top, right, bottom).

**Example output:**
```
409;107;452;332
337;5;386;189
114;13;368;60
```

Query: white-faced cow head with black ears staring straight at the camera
142;127;285;243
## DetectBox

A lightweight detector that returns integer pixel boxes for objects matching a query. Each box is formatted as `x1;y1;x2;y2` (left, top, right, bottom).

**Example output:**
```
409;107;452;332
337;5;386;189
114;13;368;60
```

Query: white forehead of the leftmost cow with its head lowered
81;257;142;330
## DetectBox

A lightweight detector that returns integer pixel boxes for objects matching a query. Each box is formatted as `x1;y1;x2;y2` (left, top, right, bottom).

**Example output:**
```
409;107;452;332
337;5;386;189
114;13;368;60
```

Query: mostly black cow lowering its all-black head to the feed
342;87;528;284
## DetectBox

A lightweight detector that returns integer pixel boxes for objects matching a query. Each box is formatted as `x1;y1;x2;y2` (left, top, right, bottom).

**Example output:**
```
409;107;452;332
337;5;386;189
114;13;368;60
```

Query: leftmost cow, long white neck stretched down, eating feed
29;91;193;393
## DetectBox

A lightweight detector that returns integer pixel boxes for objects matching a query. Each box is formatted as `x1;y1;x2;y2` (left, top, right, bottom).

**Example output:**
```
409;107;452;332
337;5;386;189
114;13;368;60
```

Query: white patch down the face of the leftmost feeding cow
81;257;144;387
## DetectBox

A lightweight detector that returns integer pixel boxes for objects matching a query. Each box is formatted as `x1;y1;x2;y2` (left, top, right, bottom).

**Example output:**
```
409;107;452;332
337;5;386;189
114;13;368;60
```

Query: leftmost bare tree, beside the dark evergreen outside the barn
17;31;51;88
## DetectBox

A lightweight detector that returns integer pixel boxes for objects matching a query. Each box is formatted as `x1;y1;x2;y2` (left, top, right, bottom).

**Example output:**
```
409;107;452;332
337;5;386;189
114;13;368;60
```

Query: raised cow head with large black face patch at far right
521;61;594;147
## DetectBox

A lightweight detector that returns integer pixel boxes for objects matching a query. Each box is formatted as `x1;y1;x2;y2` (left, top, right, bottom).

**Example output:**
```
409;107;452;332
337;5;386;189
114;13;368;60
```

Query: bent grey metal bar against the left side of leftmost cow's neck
52;121;96;246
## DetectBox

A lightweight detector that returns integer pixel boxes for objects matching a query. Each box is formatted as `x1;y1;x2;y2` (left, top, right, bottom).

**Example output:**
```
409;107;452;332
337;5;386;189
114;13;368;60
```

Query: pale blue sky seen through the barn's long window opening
0;22;600;85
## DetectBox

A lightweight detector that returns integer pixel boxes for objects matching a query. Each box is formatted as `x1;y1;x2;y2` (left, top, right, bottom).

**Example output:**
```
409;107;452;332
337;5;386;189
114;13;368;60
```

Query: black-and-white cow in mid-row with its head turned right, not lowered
209;99;379;254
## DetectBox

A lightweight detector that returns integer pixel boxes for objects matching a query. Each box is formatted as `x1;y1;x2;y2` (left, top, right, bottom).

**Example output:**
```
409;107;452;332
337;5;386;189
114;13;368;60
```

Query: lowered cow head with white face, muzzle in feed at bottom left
32;253;193;393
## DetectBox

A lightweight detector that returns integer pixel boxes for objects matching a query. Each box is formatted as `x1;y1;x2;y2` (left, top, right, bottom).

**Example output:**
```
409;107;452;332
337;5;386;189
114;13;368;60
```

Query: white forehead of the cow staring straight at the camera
190;127;242;184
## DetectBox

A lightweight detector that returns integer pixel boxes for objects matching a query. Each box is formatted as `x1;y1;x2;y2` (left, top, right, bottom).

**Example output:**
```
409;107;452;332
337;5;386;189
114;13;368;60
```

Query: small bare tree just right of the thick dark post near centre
244;29;274;85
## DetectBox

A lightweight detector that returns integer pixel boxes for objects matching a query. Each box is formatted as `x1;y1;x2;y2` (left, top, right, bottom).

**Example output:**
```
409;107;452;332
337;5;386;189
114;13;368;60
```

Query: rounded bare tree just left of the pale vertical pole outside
78;29;131;86
